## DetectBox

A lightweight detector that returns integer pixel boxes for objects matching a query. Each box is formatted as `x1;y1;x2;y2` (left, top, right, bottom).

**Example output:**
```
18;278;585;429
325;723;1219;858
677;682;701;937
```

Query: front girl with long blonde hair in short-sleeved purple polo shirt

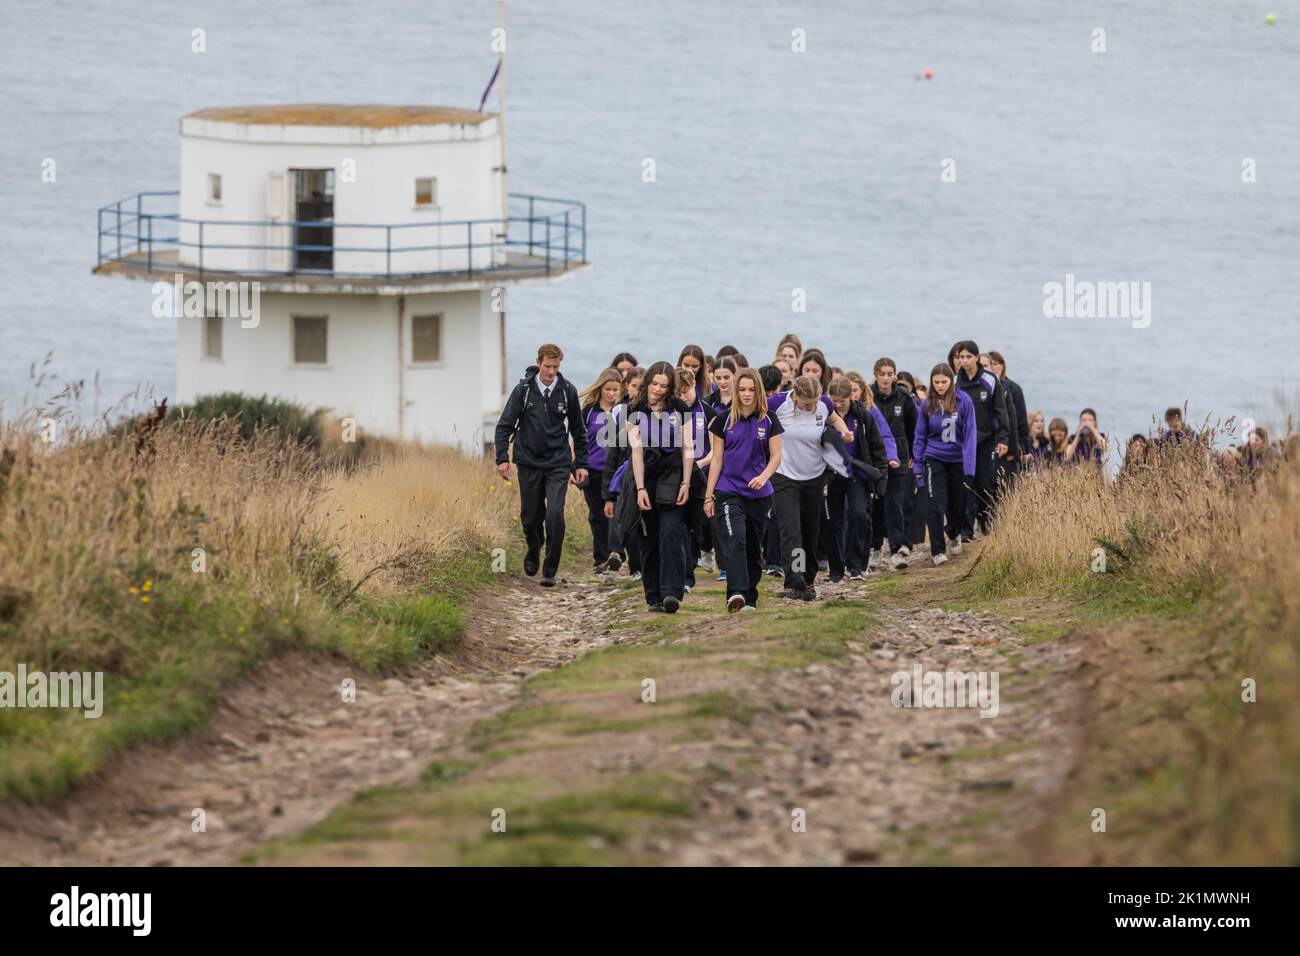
705;368;783;611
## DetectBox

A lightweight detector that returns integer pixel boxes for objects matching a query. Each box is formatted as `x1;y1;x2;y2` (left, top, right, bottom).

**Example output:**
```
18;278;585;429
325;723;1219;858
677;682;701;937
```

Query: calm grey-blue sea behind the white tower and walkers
0;0;1300;447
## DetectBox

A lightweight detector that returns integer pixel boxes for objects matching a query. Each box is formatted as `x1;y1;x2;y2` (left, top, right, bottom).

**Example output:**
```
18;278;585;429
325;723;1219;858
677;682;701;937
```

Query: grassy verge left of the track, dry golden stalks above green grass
0;408;517;801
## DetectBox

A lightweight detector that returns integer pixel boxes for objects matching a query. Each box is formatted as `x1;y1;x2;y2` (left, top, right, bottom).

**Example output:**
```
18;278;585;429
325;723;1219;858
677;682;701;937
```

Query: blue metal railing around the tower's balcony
98;190;586;278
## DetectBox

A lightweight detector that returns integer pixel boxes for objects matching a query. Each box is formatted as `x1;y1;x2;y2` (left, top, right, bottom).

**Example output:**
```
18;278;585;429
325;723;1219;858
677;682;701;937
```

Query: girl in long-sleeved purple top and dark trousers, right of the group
911;362;978;566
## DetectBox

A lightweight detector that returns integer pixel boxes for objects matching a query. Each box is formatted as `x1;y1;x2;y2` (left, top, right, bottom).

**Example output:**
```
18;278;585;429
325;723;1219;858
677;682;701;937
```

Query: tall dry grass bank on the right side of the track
974;429;1300;865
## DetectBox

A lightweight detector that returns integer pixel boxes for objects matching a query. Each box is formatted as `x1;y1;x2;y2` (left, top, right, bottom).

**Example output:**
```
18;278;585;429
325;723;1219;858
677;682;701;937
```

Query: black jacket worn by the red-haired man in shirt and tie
497;365;586;471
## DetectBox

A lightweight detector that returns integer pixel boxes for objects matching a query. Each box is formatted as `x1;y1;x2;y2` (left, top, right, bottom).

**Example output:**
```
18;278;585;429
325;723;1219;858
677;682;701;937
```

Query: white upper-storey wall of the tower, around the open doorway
180;117;502;274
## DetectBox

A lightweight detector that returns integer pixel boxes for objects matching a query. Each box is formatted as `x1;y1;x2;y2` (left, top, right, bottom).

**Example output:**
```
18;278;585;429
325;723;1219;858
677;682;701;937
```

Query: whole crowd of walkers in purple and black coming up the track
495;334;1106;614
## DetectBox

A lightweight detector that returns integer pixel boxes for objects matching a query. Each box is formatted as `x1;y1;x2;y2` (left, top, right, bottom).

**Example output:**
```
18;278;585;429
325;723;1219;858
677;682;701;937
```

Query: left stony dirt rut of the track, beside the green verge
0;580;618;865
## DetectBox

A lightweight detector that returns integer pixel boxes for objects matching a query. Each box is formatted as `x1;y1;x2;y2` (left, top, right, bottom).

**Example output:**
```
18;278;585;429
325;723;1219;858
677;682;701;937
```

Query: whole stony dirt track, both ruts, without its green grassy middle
0;554;1084;865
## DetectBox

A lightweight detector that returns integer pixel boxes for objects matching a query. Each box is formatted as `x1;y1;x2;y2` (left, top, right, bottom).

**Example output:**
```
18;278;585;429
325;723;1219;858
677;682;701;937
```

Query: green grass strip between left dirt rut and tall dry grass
0;561;490;803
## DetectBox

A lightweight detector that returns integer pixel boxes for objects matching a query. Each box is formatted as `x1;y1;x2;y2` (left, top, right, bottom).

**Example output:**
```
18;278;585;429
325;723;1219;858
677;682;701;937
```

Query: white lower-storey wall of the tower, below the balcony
176;290;514;453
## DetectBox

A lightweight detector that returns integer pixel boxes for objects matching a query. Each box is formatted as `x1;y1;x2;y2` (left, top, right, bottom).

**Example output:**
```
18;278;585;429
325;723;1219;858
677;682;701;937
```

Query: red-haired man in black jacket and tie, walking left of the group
497;343;586;588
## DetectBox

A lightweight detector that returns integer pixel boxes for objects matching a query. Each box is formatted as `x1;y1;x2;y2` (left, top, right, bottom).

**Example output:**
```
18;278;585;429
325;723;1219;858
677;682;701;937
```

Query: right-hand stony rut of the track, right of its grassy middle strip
668;609;1079;865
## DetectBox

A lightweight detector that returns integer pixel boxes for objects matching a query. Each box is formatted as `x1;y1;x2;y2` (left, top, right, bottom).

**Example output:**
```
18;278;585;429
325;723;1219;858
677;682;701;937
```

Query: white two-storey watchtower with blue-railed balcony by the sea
95;104;588;450
